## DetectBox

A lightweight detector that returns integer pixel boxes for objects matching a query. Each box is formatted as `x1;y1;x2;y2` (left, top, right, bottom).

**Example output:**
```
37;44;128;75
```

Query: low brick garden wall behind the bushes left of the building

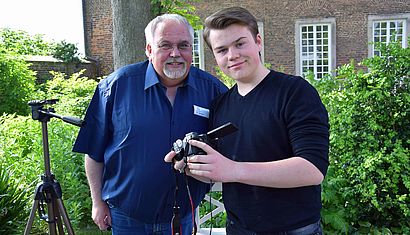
26;56;98;83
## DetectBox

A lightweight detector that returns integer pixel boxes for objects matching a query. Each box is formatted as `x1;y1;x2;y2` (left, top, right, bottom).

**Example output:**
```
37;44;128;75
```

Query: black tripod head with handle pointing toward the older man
28;99;85;127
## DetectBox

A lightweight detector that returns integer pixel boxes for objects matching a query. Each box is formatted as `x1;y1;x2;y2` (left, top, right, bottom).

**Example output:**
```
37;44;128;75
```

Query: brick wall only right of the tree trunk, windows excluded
192;0;410;74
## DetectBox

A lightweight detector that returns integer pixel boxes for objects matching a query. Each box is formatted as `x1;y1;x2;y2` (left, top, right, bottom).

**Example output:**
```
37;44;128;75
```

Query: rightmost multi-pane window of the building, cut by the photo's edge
369;14;410;57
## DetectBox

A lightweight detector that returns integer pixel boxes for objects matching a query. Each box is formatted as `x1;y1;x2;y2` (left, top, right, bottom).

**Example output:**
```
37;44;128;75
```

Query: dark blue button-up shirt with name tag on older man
73;61;227;223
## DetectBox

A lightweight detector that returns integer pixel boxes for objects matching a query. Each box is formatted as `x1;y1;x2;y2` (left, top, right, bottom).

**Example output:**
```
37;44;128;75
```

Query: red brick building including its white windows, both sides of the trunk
83;0;410;78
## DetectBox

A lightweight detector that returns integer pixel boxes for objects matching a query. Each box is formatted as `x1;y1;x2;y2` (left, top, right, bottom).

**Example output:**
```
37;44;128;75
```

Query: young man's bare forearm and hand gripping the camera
188;140;324;188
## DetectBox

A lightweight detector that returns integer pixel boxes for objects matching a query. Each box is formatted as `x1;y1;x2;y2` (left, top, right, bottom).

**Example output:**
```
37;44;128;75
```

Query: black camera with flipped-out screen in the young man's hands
172;122;238;161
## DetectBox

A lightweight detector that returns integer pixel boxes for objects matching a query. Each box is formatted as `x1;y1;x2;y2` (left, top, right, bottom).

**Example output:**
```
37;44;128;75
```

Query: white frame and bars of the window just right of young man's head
295;18;336;79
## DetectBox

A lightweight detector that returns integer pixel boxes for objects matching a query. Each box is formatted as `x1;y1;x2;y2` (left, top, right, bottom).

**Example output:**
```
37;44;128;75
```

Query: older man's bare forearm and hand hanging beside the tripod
84;154;111;230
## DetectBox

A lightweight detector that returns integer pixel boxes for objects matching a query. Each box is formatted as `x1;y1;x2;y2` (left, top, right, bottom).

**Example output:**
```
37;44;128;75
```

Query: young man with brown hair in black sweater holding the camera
165;7;329;235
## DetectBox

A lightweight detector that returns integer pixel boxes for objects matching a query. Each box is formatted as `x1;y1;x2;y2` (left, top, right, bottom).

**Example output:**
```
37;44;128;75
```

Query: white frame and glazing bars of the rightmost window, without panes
367;13;410;57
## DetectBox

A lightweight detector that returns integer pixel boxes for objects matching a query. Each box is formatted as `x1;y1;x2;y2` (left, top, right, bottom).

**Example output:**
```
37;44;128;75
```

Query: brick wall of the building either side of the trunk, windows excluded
83;0;410;74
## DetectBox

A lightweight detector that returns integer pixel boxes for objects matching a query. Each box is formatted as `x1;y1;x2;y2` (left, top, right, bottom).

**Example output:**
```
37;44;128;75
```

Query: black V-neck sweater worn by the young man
210;71;329;233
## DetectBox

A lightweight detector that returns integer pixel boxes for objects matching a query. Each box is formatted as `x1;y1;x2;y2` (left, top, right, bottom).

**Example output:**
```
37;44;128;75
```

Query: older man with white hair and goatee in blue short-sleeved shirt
74;14;227;235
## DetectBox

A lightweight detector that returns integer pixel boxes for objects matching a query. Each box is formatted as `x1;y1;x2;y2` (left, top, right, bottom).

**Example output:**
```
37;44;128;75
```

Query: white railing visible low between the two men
195;183;226;235
